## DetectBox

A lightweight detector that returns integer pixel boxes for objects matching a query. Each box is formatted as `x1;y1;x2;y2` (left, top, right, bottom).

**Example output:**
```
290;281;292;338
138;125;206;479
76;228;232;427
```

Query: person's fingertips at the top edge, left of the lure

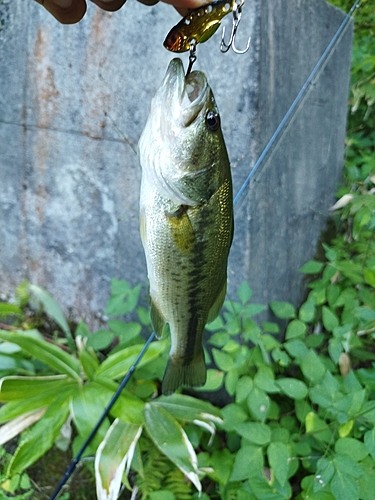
35;0;207;24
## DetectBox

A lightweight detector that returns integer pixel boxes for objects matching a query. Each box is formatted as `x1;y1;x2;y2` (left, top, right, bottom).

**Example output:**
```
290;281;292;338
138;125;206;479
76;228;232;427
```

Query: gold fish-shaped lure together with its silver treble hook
164;0;250;54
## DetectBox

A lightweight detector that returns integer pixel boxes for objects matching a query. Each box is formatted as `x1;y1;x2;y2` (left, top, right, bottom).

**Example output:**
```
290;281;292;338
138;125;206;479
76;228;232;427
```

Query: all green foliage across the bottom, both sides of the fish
0;262;375;500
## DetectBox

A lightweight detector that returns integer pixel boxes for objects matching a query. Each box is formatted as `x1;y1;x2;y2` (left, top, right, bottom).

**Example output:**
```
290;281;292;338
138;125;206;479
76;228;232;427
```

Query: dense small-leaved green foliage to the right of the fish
197;280;375;500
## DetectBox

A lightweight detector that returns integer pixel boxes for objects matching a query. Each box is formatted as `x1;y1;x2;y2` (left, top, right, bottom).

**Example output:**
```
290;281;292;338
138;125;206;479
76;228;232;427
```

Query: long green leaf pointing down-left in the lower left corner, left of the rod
7;395;69;476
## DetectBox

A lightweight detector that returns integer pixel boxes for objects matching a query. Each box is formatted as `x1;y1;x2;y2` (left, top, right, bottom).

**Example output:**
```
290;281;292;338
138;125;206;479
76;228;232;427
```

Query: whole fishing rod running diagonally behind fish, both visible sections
50;0;361;500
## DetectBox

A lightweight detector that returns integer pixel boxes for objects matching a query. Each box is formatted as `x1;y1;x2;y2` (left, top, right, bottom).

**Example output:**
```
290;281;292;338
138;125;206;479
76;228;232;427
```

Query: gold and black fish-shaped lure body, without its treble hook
164;0;237;52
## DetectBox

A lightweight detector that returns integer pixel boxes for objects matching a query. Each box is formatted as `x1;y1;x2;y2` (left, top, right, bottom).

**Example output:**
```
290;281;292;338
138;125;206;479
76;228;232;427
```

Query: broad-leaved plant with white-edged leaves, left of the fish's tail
0;280;222;500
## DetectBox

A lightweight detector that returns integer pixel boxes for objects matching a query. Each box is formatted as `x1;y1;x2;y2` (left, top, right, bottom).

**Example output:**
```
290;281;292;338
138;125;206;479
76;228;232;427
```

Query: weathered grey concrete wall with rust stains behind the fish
0;0;351;324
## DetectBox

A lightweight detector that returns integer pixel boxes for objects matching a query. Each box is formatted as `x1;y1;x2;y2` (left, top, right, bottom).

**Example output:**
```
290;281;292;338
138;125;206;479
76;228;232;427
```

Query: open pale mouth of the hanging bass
161;58;209;127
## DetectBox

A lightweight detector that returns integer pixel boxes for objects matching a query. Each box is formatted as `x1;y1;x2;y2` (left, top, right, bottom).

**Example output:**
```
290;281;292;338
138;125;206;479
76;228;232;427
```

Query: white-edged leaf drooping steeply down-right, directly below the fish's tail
144;403;202;492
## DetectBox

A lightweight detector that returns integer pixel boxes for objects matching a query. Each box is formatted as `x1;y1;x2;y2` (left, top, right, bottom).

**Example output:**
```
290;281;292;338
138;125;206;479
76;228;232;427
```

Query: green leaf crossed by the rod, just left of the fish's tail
97;340;168;379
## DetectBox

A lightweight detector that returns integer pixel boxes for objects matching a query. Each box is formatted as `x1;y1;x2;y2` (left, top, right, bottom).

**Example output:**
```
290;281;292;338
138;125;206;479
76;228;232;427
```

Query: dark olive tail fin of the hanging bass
162;349;207;395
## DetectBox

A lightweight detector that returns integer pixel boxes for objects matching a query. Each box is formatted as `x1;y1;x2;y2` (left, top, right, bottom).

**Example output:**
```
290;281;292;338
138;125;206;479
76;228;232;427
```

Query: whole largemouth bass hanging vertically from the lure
138;58;234;395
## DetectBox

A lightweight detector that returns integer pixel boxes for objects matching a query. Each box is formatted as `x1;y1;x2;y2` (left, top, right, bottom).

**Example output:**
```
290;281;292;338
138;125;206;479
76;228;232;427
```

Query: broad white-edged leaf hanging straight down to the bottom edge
95;419;142;500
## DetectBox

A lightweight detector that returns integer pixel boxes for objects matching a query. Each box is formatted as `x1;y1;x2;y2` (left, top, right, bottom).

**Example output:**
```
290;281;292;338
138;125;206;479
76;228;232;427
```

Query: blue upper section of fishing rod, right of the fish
233;0;361;206
